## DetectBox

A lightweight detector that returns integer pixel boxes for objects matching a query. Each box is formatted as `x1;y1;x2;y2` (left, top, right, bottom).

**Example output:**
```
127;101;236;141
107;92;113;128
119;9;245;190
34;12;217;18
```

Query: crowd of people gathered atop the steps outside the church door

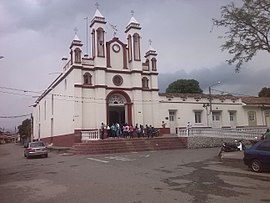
101;123;159;139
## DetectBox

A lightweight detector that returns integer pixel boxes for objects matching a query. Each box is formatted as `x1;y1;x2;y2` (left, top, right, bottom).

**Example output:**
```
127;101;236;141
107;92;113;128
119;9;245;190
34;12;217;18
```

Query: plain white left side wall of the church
33;69;75;138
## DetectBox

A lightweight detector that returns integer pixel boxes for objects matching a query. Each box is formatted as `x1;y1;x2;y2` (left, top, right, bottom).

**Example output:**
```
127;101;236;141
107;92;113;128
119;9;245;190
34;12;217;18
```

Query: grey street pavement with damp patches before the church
0;144;270;203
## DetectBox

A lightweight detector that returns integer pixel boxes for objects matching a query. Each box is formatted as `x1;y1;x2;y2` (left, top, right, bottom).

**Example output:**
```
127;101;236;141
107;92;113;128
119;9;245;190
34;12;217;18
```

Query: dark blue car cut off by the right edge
243;140;270;172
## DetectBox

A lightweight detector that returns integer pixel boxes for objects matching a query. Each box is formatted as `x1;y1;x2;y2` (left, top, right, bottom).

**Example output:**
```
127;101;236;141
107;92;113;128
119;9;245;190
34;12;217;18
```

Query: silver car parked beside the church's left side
24;141;48;158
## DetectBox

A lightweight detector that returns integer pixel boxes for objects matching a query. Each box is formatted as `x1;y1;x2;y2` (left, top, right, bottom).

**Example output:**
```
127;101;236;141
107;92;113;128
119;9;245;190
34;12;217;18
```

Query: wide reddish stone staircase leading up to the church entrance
70;137;187;155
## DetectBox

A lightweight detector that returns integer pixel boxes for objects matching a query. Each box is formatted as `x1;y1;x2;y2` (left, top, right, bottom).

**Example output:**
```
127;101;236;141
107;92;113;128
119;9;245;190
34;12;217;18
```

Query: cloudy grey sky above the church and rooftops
0;0;270;130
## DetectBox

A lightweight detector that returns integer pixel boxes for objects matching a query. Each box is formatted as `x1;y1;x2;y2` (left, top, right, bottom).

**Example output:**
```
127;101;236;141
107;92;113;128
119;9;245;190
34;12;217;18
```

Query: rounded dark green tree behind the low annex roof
166;79;203;93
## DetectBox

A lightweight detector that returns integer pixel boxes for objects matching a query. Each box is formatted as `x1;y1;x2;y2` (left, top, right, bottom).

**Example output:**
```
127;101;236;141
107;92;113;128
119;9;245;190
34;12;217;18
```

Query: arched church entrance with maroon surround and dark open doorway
106;91;132;124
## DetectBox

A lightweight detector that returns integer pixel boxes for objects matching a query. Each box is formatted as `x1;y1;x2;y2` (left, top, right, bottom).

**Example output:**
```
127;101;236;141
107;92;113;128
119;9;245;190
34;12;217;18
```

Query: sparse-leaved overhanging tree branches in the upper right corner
213;0;270;72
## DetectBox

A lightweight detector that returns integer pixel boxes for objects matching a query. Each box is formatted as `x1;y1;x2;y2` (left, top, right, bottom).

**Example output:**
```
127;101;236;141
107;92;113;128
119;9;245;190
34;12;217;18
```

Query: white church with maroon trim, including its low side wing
33;9;270;146
